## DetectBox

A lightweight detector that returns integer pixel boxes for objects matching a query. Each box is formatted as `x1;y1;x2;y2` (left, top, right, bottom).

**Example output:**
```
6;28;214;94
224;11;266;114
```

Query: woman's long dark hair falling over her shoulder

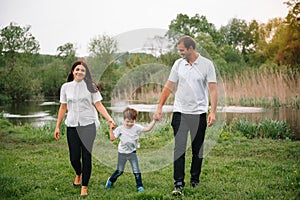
67;60;99;93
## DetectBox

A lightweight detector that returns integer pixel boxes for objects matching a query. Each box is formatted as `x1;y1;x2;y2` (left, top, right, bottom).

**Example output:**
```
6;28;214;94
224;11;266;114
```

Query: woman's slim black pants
67;124;96;186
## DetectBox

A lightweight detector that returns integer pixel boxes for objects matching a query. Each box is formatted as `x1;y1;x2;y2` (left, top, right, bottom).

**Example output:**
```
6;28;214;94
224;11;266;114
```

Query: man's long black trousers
171;112;207;186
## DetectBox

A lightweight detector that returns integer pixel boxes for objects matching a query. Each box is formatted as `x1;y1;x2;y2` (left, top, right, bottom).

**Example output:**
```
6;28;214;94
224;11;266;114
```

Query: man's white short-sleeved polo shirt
168;55;217;114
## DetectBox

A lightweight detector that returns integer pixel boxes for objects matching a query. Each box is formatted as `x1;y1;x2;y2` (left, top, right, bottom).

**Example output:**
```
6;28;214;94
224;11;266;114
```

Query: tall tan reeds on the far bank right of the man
223;67;300;108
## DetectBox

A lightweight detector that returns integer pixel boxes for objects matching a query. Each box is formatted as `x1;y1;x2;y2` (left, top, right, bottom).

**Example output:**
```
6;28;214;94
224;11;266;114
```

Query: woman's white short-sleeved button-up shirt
60;81;102;127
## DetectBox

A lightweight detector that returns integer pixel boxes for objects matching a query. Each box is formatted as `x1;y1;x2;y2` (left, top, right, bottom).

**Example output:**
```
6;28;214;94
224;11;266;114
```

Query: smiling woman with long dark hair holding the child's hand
54;61;115;196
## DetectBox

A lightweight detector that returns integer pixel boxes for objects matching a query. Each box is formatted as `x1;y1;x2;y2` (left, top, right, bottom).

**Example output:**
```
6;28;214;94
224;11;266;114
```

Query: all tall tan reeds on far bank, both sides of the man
112;65;300;109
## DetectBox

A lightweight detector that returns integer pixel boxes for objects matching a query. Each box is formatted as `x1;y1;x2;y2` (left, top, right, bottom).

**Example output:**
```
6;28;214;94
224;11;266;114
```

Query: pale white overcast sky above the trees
0;0;288;56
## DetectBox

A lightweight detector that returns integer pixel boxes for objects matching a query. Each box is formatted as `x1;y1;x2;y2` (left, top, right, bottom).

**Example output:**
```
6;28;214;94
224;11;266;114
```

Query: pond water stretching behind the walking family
0;101;300;140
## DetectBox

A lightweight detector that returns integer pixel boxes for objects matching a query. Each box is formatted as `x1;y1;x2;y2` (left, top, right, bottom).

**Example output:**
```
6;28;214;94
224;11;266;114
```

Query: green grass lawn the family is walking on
0;119;300;200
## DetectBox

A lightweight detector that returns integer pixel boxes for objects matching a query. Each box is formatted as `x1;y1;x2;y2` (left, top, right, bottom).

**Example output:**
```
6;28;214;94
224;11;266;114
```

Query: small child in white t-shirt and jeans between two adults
105;107;155;192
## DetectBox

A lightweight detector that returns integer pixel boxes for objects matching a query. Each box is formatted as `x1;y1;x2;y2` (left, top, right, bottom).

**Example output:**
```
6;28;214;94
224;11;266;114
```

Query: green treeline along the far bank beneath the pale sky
0;0;300;104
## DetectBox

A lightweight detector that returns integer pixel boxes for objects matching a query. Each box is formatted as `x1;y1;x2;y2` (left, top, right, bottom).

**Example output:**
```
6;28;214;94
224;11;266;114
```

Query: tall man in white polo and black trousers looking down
154;36;217;195
